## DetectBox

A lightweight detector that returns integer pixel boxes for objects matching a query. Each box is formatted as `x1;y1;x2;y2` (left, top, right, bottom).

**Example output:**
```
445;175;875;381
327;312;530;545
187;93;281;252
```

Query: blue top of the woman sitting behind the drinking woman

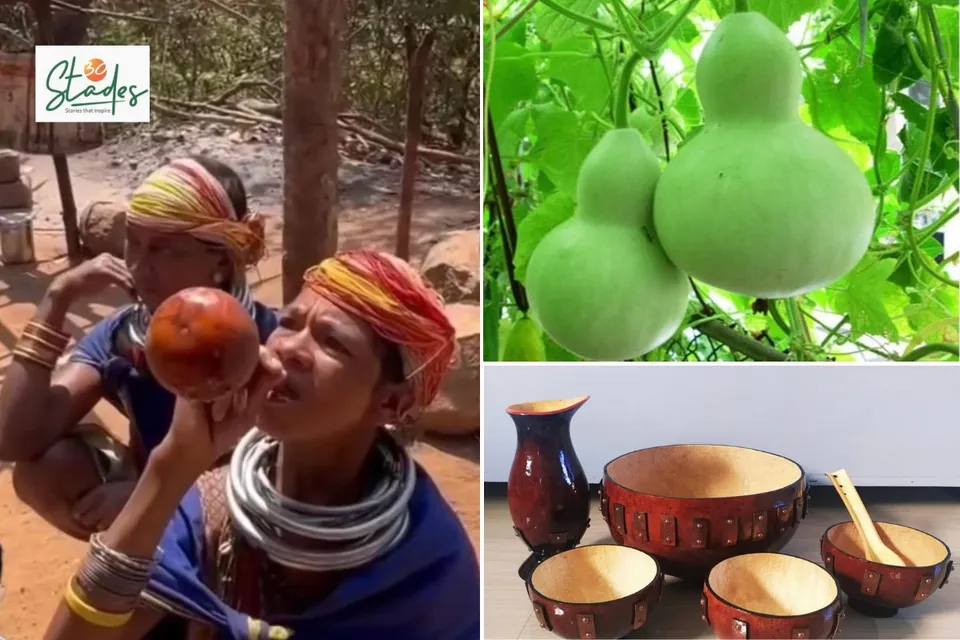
70;302;277;454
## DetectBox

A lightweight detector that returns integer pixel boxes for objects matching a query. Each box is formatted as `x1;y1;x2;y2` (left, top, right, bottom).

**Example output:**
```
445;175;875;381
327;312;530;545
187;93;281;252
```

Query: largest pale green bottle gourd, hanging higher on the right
654;12;875;298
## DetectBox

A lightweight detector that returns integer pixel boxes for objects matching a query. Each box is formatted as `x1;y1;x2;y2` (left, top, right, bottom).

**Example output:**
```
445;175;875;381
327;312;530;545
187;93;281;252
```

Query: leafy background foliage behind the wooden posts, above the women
0;0;480;148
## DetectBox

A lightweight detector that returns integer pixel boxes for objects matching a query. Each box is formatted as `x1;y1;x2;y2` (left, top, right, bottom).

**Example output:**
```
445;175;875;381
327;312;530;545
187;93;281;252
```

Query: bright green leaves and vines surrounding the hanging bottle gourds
484;0;960;360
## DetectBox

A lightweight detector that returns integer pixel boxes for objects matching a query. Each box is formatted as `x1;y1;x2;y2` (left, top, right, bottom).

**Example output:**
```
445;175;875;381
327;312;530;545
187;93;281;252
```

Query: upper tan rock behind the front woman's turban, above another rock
420;229;480;304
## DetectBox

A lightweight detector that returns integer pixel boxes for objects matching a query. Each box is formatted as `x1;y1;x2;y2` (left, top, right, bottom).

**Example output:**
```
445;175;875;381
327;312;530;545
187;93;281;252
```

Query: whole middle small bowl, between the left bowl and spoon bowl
700;553;843;640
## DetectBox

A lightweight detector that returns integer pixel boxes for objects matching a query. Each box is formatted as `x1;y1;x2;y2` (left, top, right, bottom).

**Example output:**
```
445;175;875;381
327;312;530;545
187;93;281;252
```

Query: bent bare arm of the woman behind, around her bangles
0;283;103;462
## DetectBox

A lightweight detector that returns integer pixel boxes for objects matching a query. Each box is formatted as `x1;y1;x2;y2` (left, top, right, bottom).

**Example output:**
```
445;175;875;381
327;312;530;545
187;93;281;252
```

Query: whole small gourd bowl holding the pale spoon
820;522;953;618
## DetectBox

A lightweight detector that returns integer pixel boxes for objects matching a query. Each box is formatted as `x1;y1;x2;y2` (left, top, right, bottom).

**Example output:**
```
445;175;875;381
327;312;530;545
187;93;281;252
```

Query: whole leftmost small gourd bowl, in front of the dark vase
527;544;663;638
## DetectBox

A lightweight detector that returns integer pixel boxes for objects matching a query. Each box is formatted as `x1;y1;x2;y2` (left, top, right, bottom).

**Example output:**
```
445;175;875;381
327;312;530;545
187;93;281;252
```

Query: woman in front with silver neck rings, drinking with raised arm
45;251;480;640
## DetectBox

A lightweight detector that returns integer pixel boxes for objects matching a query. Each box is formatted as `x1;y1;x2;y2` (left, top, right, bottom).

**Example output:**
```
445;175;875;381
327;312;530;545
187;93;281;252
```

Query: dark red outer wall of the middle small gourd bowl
700;568;843;640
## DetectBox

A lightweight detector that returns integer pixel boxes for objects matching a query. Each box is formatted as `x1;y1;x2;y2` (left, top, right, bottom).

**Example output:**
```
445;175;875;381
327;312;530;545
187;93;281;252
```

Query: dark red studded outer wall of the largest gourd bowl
600;444;809;580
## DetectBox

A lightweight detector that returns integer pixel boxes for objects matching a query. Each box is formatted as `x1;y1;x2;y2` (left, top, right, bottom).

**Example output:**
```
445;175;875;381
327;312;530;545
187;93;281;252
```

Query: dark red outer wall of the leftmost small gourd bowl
527;547;663;640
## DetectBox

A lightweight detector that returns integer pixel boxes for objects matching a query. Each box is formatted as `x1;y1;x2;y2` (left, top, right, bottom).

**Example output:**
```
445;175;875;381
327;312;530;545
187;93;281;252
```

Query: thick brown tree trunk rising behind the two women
283;0;346;303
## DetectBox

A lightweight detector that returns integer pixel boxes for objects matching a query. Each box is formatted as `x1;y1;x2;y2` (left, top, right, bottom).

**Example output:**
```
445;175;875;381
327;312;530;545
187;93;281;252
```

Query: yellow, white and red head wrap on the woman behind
127;158;264;265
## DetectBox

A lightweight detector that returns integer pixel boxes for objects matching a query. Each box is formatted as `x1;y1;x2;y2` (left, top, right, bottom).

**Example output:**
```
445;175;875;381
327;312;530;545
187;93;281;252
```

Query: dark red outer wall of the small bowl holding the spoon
820;522;953;618
